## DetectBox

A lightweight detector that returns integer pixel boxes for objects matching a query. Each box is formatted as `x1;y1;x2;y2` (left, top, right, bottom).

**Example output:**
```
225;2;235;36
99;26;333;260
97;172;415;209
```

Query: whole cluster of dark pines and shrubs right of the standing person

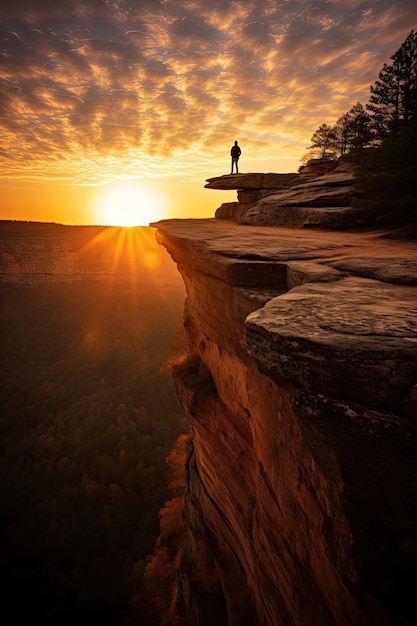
304;31;417;232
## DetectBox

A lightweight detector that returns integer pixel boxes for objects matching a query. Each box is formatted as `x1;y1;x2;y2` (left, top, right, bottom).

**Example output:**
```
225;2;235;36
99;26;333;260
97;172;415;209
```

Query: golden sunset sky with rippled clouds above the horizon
0;0;417;225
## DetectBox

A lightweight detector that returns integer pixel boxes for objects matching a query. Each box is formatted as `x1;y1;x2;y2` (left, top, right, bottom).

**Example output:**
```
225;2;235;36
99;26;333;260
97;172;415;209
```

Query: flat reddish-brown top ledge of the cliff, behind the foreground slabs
151;218;417;266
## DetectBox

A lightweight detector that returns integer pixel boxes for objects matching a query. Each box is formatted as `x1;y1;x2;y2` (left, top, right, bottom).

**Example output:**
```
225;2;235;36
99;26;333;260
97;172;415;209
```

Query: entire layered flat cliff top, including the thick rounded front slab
153;218;417;410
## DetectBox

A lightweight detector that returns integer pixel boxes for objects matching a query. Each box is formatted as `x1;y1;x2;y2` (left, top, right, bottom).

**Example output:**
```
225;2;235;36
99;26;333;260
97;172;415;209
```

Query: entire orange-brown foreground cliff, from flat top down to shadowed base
156;219;417;626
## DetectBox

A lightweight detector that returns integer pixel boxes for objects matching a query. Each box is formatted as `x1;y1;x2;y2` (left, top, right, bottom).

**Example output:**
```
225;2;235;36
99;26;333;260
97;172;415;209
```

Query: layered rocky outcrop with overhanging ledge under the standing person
210;158;363;228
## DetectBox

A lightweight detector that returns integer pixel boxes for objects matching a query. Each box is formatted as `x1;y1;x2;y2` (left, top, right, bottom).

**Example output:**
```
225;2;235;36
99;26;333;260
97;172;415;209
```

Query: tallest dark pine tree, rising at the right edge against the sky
366;30;417;139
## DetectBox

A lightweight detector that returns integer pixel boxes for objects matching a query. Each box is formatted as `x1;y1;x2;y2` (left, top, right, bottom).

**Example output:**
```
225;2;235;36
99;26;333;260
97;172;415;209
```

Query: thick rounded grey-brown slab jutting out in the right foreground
245;277;417;409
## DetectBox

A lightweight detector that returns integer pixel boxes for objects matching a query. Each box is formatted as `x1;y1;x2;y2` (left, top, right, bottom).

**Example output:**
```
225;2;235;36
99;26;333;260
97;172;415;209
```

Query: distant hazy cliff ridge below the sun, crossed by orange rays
0;221;178;286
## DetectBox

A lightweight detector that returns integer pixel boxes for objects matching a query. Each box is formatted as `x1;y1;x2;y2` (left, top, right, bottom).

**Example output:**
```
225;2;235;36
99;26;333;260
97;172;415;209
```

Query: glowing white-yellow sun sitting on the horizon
94;182;164;226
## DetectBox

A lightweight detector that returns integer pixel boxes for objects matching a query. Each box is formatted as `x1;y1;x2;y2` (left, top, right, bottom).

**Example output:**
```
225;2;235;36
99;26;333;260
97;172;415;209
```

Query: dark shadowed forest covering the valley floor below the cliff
0;281;188;626
